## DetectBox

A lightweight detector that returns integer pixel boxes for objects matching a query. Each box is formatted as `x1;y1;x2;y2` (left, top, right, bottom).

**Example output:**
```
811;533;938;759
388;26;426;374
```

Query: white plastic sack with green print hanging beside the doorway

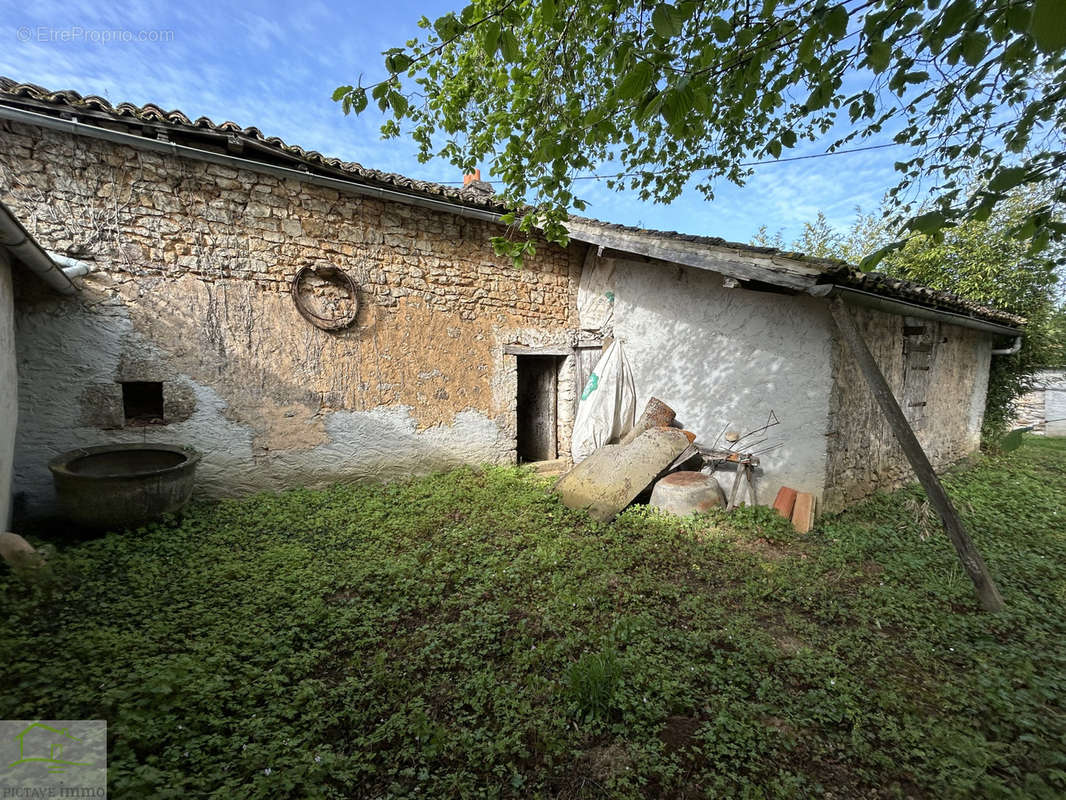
570;341;636;464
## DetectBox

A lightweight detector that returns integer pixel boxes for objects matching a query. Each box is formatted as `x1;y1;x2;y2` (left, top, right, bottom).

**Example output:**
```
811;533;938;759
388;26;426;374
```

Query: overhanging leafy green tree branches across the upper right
334;0;1066;266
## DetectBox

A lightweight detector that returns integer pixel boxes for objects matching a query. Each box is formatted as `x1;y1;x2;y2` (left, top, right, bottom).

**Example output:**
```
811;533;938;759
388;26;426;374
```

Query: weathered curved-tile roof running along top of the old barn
0;76;1025;326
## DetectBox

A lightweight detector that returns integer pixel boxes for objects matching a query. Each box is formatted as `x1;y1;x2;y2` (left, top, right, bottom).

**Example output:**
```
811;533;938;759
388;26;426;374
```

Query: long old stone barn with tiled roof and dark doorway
0;79;1023;526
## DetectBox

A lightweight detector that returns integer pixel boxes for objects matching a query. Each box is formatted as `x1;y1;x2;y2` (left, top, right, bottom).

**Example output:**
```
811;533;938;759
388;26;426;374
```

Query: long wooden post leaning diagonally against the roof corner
829;298;1003;611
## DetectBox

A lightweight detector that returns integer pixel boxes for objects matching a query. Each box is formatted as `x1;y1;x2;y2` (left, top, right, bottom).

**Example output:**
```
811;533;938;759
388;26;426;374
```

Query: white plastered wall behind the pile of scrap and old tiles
614;261;830;505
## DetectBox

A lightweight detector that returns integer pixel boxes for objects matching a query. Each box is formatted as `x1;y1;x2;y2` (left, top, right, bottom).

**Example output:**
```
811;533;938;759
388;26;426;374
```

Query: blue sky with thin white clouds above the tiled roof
0;0;903;241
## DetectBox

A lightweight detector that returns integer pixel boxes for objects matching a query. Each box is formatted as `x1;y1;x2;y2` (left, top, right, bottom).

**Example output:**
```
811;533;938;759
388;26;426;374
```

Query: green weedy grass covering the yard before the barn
6;437;1066;798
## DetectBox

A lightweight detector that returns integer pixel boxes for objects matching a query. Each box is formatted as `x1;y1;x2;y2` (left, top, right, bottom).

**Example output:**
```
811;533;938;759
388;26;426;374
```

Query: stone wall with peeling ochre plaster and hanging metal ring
0;123;584;512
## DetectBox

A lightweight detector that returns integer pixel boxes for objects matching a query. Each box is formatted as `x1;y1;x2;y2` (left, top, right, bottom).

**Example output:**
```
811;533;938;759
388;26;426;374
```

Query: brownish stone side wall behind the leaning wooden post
824;306;991;511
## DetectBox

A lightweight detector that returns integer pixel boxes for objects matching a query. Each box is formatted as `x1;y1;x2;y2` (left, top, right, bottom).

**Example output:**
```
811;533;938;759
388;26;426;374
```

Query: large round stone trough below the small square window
48;445;200;528
